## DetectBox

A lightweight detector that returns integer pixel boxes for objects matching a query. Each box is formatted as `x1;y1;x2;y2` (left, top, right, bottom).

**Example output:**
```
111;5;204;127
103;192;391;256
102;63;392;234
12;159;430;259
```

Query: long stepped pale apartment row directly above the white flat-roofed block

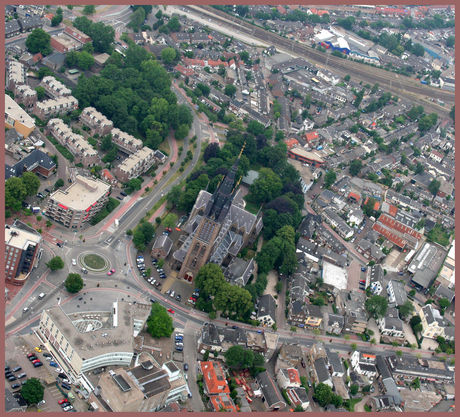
47;119;101;167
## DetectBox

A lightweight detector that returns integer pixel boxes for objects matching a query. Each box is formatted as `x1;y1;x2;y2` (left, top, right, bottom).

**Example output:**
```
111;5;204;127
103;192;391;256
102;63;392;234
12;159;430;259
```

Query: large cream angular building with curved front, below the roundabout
38;301;150;380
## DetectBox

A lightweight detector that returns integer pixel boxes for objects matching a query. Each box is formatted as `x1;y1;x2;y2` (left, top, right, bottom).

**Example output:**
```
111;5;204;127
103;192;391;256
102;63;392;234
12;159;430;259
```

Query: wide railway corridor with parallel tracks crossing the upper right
189;6;455;116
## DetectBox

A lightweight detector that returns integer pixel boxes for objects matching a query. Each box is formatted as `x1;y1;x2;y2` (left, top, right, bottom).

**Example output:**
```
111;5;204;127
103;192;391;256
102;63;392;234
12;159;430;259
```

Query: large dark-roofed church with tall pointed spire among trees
171;150;263;285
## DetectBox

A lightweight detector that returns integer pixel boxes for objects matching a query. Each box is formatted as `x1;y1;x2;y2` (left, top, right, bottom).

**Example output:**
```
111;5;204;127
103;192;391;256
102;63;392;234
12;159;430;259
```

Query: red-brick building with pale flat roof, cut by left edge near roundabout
5;220;43;285
